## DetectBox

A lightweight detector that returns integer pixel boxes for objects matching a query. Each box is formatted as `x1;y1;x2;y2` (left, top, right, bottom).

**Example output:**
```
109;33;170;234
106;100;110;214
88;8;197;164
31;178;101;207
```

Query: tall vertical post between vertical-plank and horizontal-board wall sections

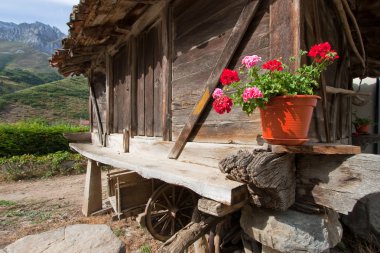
161;5;173;141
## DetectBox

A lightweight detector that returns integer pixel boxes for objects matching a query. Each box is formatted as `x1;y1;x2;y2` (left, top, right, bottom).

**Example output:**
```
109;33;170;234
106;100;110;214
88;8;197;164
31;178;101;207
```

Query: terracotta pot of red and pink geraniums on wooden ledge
213;42;339;145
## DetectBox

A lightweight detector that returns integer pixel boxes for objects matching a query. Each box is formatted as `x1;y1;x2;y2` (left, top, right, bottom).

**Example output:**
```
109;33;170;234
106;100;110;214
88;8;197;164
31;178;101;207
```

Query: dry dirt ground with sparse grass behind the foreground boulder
0;174;160;253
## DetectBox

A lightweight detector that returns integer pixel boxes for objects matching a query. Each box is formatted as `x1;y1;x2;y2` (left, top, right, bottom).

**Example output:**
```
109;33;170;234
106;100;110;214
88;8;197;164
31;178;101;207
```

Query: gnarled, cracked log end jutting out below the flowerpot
219;151;296;210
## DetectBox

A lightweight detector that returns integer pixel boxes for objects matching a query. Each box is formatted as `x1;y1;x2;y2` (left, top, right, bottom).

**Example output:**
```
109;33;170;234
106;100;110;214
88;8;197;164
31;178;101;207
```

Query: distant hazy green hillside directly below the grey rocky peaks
0;41;62;95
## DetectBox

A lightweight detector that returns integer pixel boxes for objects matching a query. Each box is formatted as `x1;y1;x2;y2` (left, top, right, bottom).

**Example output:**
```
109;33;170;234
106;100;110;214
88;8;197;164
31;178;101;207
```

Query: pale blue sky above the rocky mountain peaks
0;0;79;34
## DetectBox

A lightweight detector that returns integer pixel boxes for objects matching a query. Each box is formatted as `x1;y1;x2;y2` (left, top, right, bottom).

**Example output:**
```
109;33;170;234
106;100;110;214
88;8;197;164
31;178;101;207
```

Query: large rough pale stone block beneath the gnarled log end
240;205;343;253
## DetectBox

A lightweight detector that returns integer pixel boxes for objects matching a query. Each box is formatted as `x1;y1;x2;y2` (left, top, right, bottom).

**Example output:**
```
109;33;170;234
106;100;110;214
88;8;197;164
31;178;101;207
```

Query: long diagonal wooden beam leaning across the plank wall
169;0;259;159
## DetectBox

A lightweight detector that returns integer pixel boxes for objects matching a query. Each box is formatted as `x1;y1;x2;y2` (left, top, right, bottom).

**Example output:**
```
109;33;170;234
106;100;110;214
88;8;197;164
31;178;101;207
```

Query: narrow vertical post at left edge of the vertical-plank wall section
106;54;114;134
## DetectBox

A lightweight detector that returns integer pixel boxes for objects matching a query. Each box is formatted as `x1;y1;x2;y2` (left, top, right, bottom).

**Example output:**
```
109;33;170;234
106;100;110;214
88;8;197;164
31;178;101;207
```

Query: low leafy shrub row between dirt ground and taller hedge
0;151;87;181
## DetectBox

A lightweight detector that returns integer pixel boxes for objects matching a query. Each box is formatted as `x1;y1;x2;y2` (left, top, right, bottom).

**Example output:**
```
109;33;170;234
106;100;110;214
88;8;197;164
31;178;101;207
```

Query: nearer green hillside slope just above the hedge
0;77;89;124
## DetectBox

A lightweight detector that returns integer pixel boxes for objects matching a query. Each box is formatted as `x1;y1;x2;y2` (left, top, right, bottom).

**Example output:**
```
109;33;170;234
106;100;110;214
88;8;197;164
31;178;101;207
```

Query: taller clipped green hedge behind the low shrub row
0;120;88;157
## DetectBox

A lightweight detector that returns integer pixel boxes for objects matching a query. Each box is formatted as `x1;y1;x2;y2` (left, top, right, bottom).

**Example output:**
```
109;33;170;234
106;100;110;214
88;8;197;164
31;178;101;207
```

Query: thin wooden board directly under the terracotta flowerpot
271;143;361;155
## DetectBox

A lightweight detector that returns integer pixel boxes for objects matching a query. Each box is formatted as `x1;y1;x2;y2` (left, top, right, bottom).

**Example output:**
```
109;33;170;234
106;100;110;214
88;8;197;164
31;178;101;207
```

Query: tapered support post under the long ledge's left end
82;159;102;216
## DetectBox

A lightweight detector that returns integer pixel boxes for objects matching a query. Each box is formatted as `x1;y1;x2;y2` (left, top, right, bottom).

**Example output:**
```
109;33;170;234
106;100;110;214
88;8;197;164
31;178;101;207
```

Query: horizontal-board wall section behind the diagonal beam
172;0;269;143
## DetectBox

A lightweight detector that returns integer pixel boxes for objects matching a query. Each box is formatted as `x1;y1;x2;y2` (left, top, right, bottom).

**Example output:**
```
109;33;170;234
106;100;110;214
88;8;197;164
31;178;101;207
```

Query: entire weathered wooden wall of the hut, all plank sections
90;0;351;144
